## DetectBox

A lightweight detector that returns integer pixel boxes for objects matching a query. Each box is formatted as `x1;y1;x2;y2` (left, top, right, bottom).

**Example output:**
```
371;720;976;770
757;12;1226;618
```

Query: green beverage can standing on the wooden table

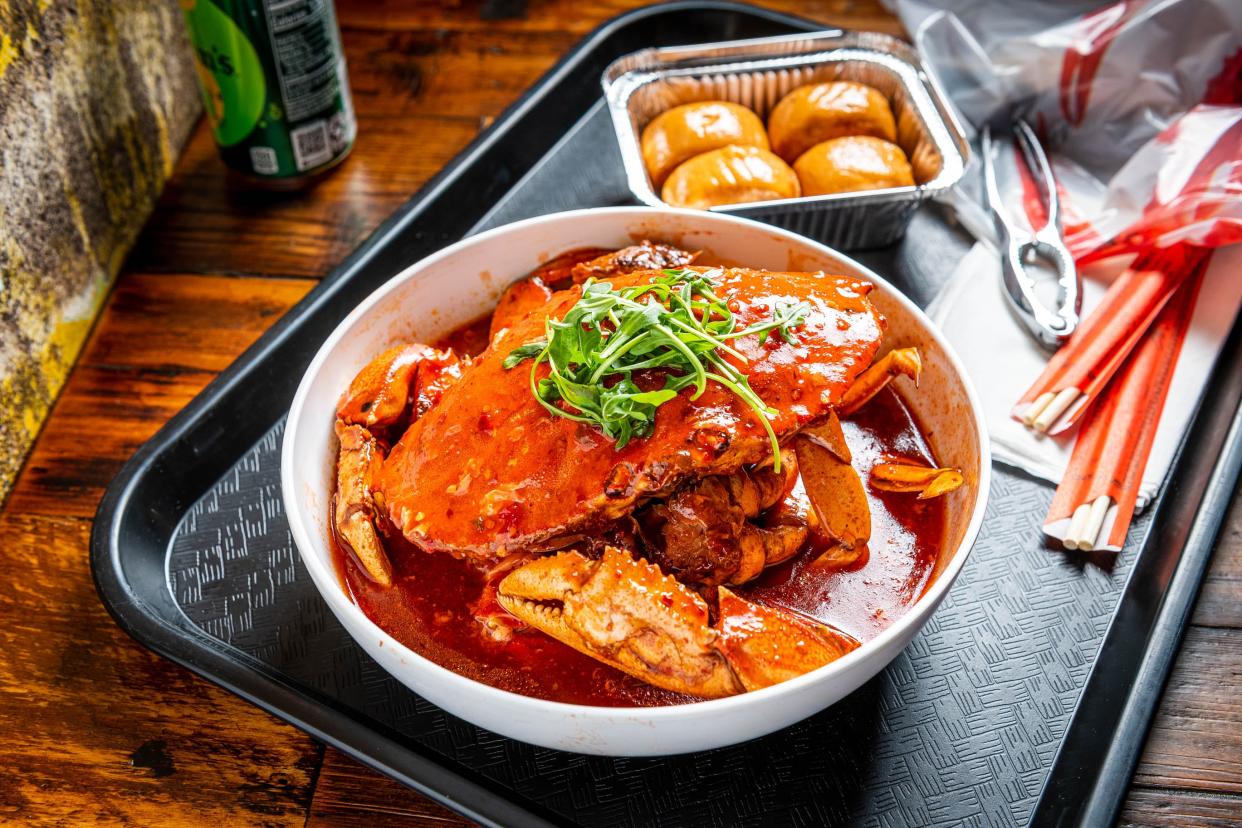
181;0;356;186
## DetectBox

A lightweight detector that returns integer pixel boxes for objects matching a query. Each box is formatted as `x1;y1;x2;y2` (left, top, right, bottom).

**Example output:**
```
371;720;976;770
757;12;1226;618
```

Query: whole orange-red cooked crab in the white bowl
333;242;920;698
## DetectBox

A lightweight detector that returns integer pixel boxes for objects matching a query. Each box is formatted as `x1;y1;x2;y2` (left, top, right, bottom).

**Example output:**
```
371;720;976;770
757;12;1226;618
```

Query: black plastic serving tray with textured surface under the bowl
91;2;1242;826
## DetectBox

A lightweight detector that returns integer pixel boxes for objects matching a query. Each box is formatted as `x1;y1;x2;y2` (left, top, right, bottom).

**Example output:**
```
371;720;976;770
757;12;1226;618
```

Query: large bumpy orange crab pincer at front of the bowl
497;546;744;698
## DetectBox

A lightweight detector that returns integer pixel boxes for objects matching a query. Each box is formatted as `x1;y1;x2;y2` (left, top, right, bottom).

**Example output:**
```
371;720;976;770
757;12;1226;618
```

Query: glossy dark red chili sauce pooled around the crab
335;256;945;706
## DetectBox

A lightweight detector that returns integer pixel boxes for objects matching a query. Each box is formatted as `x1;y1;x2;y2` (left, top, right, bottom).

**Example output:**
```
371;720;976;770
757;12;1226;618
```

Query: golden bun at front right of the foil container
794;135;914;196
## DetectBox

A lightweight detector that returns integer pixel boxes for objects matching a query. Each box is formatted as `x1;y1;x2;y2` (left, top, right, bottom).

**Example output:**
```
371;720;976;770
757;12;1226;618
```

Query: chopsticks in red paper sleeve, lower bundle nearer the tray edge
1043;254;1208;551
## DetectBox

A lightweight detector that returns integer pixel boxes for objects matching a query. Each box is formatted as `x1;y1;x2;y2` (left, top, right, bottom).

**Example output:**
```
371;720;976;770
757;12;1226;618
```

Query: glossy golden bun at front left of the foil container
661;145;801;210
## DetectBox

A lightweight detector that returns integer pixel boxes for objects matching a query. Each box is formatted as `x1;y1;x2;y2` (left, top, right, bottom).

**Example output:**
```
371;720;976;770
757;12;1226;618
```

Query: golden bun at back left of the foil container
642;101;768;189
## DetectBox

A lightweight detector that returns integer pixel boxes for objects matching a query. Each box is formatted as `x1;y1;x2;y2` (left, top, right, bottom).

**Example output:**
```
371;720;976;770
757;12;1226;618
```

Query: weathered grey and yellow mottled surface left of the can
0;0;200;500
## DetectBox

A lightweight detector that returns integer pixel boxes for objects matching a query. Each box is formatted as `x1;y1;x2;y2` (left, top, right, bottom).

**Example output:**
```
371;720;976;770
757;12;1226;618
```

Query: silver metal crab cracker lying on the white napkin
981;120;1082;350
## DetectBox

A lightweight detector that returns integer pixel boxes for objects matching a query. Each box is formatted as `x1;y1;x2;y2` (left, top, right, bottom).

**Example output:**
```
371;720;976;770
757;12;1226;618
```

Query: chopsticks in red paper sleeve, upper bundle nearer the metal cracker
1011;245;1207;434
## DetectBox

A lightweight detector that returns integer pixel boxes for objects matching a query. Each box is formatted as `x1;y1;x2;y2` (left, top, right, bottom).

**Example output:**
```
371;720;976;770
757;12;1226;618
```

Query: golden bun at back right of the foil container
768;81;897;164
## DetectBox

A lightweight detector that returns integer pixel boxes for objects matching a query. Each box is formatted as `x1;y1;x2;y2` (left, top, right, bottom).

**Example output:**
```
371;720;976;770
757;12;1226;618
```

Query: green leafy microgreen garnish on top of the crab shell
504;269;811;470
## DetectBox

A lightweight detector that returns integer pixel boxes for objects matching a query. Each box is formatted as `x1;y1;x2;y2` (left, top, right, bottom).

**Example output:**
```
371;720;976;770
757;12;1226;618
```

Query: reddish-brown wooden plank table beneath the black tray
0;0;1242;824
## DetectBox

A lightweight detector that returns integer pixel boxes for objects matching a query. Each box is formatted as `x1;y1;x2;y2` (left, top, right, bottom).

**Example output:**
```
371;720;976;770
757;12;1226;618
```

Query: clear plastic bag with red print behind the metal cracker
895;0;1242;262
